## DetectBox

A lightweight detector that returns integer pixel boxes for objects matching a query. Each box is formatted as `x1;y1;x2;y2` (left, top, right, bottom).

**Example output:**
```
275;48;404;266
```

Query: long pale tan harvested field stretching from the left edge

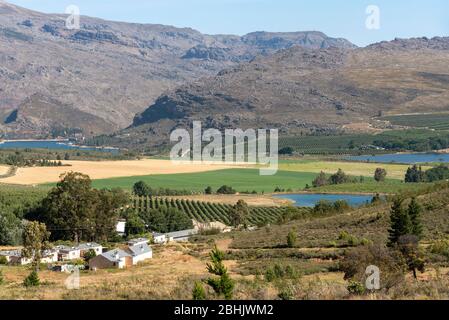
0;159;235;185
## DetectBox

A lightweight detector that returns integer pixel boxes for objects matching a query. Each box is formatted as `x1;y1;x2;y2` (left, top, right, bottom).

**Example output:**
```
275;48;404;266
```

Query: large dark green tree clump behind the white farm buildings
33;172;128;242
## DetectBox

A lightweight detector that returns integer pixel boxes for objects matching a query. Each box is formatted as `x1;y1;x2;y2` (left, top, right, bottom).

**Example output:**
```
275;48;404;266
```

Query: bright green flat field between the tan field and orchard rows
89;169;316;193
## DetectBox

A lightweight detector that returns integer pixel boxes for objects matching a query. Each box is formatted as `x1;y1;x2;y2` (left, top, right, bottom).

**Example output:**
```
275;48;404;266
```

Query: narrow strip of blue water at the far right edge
347;153;449;164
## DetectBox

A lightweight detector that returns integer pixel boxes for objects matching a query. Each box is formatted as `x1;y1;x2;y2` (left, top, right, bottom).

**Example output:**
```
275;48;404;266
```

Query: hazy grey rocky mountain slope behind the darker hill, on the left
0;1;354;137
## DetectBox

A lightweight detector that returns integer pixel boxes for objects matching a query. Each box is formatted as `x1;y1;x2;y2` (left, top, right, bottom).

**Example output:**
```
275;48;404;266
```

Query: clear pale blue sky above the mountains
7;0;449;46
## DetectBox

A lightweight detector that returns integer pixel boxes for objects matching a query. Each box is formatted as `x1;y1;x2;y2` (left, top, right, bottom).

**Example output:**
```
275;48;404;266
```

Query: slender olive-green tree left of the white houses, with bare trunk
22;221;51;271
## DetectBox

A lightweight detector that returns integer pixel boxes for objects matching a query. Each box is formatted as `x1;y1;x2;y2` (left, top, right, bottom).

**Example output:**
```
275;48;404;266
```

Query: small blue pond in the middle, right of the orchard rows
275;193;373;207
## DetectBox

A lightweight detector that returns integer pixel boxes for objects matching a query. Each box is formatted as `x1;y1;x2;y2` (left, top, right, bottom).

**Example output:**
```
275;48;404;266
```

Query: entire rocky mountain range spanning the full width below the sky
0;2;449;145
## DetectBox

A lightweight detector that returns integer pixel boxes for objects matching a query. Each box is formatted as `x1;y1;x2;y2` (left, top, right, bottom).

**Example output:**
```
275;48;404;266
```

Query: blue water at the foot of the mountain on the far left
0;140;119;153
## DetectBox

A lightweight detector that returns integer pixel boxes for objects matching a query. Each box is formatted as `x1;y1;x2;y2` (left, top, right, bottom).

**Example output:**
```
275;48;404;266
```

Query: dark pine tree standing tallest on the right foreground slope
388;198;412;246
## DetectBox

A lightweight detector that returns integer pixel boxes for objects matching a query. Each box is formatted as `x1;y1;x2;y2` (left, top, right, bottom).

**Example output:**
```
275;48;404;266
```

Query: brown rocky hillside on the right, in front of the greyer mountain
122;38;449;149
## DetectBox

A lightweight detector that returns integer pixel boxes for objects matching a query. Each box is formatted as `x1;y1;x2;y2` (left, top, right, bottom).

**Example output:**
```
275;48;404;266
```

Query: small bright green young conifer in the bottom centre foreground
207;246;234;300
